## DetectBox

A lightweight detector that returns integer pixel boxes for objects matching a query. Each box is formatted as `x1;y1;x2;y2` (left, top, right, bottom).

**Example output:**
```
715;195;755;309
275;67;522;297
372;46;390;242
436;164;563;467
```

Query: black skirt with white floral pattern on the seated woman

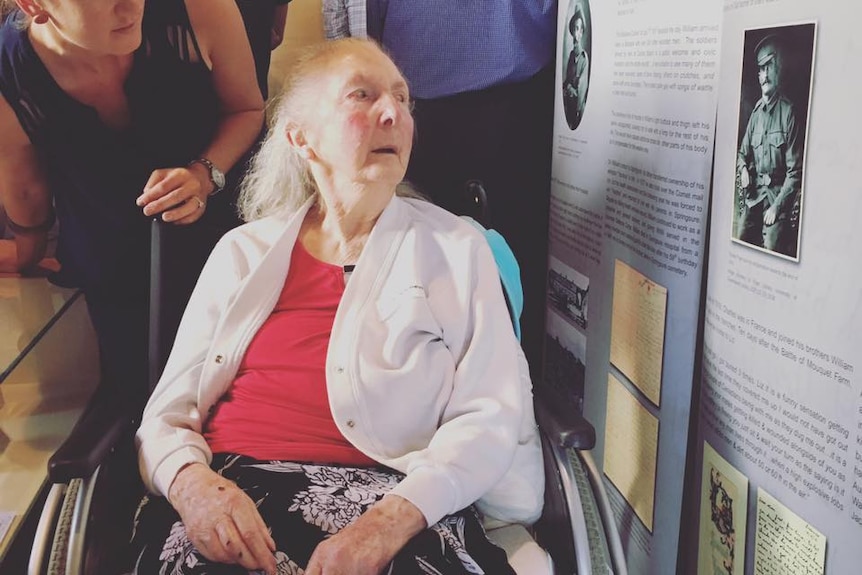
132;454;514;575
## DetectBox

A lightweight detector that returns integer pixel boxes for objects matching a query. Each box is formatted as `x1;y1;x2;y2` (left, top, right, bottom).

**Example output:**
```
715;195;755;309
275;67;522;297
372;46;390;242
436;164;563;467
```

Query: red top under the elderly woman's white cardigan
204;241;377;466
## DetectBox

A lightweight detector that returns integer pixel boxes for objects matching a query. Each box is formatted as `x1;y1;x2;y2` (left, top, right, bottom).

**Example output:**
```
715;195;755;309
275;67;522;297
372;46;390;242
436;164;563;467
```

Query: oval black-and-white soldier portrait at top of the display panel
561;0;593;130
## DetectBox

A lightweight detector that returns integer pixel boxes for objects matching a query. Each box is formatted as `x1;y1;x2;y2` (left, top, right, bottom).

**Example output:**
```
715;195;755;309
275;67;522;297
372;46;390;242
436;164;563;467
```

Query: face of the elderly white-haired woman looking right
307;46;413;188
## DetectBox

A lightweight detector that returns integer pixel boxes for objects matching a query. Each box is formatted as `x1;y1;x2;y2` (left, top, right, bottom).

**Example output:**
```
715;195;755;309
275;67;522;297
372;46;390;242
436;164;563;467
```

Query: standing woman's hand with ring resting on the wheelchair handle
135;168;208;224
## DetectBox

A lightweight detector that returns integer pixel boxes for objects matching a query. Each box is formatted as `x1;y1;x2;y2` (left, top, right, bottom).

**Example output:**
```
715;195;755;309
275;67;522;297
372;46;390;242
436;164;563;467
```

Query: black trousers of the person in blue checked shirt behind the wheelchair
407;68;554;378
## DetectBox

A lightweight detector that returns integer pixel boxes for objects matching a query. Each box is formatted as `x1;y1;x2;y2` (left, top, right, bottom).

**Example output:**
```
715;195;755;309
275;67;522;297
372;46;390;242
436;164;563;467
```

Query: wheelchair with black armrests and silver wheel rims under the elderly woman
27;187;627;575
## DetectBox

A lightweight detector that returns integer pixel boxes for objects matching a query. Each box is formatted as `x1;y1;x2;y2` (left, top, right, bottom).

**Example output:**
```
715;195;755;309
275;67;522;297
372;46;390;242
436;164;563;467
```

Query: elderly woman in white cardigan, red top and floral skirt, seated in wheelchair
133;39;544;575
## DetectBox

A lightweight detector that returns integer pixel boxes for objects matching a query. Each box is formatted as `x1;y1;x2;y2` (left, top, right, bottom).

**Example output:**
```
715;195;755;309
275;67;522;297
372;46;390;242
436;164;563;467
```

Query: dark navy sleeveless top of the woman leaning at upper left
0;0;226;299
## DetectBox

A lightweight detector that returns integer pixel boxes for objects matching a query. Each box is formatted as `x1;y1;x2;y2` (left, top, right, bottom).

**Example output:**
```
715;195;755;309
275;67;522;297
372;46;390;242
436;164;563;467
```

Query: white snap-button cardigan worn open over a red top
136;197;544;525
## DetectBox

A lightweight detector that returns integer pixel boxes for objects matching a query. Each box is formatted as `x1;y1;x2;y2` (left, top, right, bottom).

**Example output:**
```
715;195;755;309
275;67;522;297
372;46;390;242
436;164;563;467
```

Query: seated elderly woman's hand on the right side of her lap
305;495;426;575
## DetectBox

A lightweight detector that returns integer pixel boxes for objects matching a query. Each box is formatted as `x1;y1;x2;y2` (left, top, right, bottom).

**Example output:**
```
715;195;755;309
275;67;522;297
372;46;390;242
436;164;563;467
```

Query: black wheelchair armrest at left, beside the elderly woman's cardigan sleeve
48;386;135;483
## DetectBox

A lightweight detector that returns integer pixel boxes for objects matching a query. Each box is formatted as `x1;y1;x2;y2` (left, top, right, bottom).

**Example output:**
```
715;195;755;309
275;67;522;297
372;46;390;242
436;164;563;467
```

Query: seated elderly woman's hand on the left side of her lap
168;463;276;574
